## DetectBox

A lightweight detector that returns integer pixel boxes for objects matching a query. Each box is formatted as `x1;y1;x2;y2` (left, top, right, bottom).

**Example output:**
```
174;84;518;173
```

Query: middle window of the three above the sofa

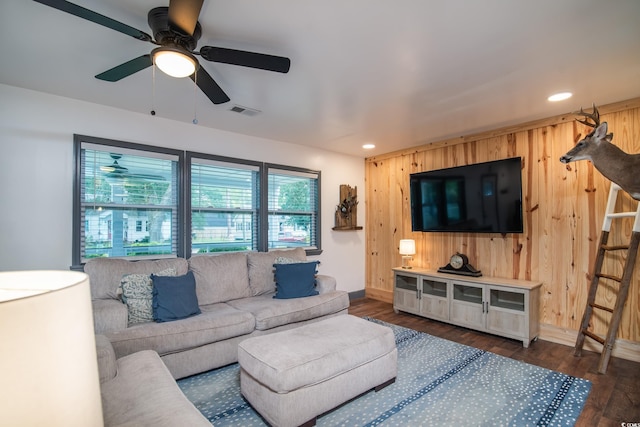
187;153;261;254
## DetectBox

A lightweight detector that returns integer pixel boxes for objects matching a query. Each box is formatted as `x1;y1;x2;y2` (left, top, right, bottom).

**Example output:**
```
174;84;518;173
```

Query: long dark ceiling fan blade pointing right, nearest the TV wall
200;46;291;73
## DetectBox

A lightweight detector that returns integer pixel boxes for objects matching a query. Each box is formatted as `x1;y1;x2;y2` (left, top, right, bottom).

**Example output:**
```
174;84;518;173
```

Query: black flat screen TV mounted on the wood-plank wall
409;157;523;234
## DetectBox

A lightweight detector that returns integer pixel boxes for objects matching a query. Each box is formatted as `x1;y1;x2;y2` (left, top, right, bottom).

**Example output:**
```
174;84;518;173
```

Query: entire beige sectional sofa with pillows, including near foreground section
84;248;349;427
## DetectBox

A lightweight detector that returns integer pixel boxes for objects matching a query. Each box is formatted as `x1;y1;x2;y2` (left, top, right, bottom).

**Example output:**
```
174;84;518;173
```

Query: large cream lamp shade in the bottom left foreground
0;271;103;427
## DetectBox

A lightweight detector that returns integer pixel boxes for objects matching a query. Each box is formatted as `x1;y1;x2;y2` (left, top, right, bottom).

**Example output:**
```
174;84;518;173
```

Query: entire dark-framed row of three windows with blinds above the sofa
72;135;322;267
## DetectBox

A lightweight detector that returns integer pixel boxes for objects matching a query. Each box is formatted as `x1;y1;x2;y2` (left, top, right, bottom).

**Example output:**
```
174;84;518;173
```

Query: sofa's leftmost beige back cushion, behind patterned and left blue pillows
84;258;189;299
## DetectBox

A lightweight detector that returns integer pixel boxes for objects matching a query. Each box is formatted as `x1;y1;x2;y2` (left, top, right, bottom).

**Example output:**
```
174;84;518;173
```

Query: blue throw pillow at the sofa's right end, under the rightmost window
273;261;318;299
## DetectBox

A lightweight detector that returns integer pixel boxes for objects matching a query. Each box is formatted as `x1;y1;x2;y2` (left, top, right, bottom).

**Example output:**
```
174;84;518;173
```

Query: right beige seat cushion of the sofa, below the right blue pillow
222;291;349;331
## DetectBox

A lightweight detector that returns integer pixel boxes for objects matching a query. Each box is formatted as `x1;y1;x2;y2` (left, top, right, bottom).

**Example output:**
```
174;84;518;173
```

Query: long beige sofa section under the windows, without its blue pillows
84;248;349;379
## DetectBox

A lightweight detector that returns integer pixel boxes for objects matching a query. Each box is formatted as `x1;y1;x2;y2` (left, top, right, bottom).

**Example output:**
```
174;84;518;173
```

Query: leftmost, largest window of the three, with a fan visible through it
73;135;183;265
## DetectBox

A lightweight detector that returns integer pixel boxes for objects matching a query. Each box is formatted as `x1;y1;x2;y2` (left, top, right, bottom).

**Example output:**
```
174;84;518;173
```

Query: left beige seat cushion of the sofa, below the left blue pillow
105;303;255;357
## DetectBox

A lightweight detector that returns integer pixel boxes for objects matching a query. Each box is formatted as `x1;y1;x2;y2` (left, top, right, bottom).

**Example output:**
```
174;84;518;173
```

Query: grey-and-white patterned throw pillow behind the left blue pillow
120;268;176;326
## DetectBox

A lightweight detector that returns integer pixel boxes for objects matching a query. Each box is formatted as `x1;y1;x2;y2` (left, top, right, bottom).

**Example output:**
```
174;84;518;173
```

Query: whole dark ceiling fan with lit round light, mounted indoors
34;0;291;104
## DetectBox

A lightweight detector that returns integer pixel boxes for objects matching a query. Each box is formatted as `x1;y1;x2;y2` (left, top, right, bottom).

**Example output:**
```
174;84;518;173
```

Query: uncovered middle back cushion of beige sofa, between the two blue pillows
189;252;252;305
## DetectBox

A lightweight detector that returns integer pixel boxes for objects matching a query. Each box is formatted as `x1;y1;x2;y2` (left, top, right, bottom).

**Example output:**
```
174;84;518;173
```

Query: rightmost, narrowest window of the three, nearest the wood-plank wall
267;165;320;253
